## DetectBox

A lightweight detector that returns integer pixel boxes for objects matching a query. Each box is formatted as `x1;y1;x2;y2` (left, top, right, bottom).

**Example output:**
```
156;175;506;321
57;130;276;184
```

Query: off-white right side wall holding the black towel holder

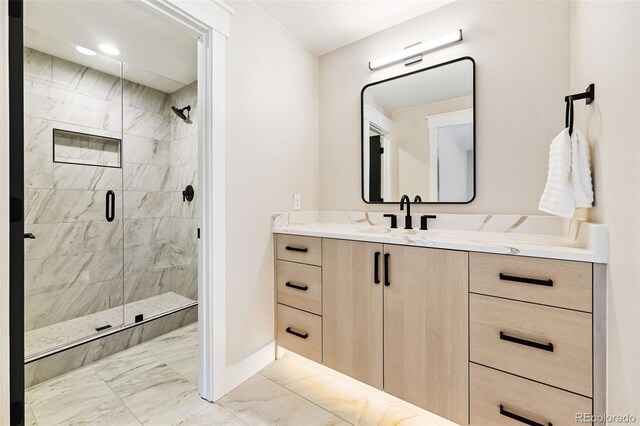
570;1;640;419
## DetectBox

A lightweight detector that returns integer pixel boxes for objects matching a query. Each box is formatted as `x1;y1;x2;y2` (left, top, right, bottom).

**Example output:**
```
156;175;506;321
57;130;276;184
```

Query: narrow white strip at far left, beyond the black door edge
0;0;9;425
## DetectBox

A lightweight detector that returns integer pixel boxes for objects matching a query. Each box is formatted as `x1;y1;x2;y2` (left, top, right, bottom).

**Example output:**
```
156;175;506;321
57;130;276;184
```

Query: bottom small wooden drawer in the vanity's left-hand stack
278;303;322;363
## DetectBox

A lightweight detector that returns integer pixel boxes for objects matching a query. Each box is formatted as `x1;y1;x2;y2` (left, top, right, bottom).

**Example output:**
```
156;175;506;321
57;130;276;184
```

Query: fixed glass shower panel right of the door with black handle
123;63;198;326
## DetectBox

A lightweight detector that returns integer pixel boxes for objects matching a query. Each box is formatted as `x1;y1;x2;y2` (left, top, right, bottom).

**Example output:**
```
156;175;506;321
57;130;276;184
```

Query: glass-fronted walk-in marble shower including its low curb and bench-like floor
24;28;198;386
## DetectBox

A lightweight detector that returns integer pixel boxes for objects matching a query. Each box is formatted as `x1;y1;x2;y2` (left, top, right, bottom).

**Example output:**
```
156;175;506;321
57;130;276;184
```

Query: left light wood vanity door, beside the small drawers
322;239;383;389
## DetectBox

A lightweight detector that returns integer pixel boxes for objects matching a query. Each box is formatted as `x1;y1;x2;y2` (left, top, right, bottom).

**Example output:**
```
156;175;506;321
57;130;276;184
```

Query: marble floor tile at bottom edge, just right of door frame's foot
218;375;348;425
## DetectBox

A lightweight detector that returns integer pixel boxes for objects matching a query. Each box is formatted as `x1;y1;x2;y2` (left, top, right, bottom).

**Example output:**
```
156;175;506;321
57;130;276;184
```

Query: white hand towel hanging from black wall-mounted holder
538;127;593;218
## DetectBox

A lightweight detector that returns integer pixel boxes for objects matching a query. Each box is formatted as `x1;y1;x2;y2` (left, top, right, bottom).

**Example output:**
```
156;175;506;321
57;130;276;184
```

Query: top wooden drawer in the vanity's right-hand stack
469;253;592;312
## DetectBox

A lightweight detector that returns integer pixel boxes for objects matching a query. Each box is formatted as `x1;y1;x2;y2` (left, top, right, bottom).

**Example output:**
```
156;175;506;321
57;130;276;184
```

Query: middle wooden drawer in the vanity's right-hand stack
469;294;592;397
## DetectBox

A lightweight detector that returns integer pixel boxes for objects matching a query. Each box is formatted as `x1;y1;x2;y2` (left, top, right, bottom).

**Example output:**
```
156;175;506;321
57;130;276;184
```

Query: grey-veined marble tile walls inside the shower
24;48;197;331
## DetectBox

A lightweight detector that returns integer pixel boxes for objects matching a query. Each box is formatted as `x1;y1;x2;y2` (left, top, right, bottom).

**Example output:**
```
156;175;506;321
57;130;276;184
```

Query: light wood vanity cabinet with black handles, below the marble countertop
276;235;606;426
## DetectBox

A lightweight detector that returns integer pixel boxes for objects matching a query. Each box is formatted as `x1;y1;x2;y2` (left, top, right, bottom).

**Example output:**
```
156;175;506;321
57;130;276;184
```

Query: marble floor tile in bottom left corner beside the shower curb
27;366;140;425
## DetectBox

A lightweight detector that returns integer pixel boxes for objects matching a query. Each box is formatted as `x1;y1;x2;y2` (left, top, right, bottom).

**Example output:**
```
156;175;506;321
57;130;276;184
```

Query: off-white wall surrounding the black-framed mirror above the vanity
320;1;569;214
